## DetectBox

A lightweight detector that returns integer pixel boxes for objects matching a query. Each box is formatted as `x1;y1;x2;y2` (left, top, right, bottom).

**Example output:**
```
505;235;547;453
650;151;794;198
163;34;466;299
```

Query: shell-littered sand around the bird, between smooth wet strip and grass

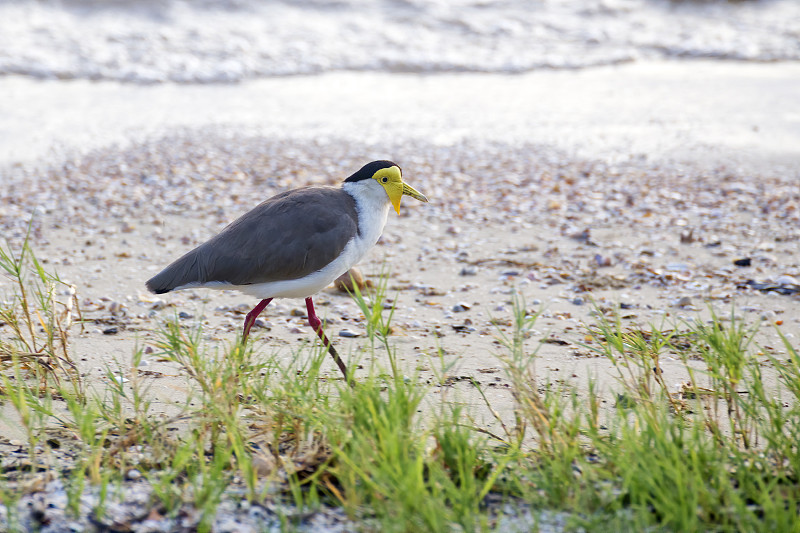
0;132;800;435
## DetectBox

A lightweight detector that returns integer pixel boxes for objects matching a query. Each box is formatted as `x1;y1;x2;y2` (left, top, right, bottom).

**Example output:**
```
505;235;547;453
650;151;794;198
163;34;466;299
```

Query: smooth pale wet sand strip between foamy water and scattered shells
0;60;800;171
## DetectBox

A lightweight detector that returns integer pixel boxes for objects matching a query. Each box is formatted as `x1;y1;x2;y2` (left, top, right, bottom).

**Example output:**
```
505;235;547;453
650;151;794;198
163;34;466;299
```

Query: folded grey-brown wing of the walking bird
147;187;358;293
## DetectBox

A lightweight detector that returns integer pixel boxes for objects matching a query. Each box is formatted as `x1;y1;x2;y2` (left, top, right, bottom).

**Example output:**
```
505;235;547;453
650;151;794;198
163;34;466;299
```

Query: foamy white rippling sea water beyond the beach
0;0;800;83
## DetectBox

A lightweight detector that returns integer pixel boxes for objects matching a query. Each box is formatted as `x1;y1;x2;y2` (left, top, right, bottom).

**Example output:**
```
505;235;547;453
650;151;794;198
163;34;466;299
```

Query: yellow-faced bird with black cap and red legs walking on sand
145;160;428;383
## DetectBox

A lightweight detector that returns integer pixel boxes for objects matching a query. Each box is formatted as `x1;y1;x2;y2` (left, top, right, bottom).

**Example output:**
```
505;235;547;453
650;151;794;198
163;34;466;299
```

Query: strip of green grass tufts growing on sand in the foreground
0;243;800;531
